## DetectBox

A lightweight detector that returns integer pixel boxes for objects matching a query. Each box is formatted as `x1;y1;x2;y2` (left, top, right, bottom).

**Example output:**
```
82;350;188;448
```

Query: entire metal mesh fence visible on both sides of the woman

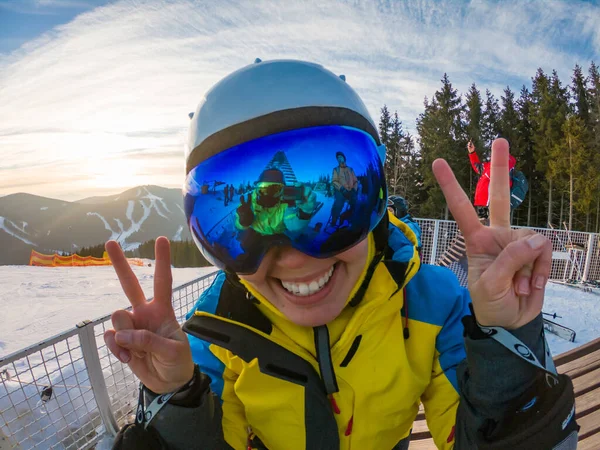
0;219;600;450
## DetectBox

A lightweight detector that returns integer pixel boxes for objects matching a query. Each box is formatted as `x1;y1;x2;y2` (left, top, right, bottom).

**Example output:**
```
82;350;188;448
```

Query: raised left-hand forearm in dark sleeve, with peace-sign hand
104;237;231;450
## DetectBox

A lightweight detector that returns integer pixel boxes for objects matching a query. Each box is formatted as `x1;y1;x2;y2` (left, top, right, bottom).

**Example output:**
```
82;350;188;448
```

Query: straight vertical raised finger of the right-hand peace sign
489;138;510;228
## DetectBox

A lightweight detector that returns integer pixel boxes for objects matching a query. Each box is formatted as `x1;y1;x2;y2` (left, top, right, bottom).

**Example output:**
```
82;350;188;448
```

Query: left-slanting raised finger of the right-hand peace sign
432;159;482;237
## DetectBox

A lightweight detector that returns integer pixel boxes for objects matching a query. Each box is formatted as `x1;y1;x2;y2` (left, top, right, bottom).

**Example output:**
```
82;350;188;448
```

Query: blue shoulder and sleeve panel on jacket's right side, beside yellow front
406;264;471;391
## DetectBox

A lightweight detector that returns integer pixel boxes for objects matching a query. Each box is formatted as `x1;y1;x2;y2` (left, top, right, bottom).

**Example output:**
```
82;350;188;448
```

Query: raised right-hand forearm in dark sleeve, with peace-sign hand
433;139;578;450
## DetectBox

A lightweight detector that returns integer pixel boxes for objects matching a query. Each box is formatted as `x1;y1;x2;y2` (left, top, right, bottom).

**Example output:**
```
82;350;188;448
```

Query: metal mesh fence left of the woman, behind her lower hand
0;274;215;450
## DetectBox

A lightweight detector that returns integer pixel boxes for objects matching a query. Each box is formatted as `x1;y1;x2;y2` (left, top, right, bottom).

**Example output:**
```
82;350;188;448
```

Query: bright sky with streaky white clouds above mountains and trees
0;0;600;200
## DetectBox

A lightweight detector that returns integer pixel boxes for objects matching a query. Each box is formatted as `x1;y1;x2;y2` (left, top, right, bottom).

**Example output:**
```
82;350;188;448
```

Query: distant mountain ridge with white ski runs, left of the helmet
0;186;191;264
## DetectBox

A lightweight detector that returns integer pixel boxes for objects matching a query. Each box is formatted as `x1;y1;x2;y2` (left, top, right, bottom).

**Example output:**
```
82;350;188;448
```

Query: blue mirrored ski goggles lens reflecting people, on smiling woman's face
184;126;387;274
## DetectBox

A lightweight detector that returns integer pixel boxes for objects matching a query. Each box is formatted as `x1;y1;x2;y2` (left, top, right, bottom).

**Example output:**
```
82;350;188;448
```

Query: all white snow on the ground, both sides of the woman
0;261;600;450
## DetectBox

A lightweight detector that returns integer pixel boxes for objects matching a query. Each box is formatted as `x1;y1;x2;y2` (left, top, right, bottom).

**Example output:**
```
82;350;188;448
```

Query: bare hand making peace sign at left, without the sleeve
104;237;194;394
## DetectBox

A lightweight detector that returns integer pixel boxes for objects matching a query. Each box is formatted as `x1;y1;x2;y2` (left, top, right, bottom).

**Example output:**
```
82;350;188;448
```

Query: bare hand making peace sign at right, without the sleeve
433;139;552;329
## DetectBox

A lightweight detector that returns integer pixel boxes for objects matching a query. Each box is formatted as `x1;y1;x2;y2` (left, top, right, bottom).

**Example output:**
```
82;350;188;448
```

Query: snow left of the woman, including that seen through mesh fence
0;266;215;450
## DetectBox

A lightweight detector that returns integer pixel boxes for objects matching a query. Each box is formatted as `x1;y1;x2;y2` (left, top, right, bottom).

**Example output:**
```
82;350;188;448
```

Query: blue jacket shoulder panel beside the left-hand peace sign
186;272;225;398
